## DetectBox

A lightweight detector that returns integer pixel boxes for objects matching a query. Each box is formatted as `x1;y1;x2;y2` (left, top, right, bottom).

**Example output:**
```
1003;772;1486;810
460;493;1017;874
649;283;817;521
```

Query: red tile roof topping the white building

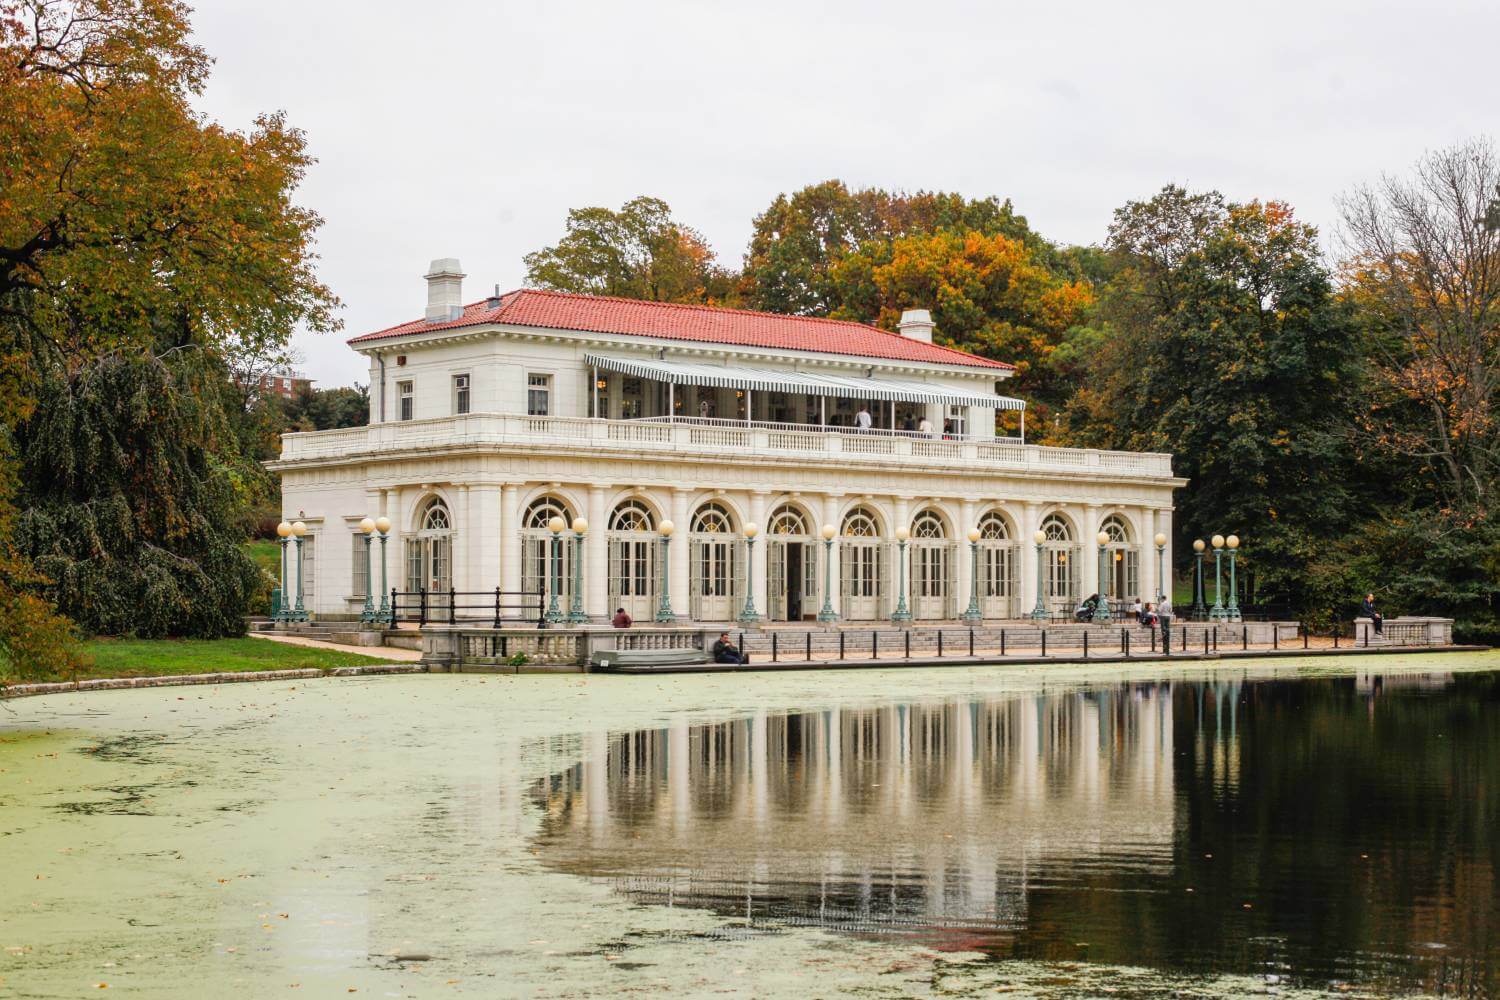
350;288;1016;370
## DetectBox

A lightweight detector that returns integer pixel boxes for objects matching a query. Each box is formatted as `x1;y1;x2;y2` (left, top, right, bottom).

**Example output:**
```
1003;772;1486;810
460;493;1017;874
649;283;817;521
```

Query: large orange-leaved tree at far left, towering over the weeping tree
0;0;338;675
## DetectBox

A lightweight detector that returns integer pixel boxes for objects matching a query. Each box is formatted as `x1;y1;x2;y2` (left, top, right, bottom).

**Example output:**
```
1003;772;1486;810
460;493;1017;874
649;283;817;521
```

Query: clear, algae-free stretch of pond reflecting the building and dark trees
533;675;1500;997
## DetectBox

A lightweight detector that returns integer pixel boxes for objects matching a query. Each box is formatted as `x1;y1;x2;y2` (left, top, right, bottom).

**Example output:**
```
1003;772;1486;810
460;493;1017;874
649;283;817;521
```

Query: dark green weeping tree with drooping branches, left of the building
17;346;261;639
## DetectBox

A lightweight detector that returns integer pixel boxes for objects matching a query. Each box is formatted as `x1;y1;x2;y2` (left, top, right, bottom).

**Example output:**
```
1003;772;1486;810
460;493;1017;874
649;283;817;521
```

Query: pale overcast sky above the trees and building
194;0;1500;385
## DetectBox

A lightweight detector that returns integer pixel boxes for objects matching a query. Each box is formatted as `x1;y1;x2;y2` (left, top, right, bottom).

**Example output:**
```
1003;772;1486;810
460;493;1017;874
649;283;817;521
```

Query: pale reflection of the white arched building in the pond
533;684;1176;948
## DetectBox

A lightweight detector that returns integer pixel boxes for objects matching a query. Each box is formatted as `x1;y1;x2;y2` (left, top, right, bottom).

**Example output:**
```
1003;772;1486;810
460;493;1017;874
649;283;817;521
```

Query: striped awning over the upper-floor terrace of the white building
584;354;1026;409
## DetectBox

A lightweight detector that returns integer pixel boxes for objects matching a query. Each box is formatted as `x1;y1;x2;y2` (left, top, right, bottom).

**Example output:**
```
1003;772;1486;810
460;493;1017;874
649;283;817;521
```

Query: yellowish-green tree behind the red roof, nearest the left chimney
525;196;734;303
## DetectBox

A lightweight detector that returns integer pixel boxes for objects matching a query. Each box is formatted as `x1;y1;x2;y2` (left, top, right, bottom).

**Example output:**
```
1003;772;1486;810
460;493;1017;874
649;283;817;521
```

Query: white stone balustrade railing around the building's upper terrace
281;414;1172;477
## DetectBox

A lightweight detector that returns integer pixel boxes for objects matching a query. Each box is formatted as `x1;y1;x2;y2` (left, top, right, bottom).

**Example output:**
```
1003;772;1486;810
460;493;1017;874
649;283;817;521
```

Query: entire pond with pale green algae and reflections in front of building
0;654;1500;997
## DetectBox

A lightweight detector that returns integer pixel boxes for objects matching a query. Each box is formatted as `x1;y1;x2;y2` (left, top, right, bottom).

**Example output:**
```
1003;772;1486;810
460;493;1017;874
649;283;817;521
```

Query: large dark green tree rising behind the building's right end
1065;186;1364;607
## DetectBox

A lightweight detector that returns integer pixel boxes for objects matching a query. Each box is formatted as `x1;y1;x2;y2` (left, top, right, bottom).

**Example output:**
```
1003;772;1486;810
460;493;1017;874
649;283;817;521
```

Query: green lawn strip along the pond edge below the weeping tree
27;639;386;679
